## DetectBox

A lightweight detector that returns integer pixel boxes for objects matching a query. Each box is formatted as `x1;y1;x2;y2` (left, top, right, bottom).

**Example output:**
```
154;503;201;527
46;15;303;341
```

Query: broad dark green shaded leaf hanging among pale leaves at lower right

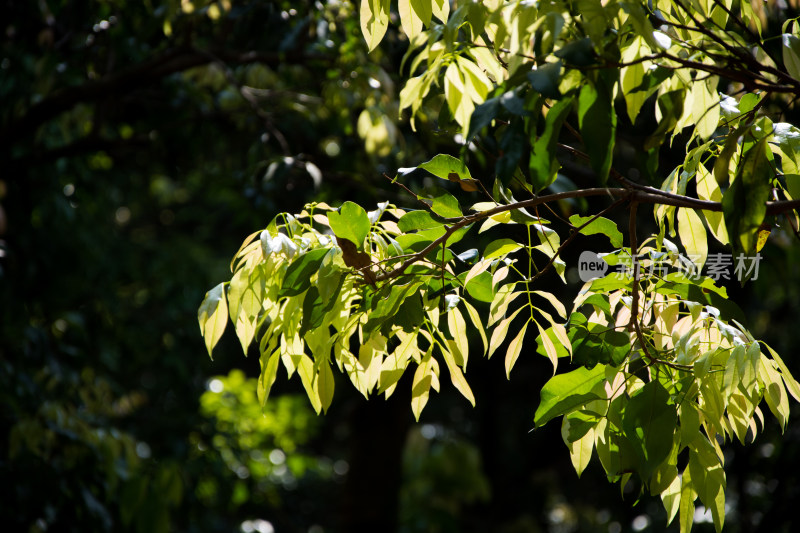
622;381;677;480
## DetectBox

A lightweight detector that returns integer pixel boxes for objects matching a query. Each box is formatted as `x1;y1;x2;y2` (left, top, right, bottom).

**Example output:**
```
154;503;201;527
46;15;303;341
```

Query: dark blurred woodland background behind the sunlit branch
0;0;800;533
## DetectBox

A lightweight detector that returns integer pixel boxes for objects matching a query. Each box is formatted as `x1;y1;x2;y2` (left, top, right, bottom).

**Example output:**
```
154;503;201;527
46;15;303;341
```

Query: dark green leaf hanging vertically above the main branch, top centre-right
578;79;617;184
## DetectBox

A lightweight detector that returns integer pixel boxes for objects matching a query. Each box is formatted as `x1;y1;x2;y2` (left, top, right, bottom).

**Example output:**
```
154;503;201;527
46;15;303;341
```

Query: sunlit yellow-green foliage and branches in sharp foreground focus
199;0;800;531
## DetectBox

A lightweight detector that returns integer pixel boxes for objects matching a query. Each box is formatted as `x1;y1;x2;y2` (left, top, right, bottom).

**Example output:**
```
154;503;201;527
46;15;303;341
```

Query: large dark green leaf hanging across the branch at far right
722;137;772;254
